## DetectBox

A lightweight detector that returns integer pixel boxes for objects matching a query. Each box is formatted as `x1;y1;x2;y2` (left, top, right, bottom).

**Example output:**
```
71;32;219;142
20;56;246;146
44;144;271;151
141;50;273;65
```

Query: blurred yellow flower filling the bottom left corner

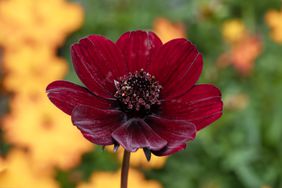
0;150;59;188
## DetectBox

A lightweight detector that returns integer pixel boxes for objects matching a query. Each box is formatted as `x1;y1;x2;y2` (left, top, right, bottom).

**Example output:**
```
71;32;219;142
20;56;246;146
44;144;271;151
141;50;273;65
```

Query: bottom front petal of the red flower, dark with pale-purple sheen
112;119;167;152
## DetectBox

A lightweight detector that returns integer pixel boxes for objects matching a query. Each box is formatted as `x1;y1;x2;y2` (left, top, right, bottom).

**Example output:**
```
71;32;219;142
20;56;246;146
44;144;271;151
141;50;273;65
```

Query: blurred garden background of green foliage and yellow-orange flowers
0;0;282;188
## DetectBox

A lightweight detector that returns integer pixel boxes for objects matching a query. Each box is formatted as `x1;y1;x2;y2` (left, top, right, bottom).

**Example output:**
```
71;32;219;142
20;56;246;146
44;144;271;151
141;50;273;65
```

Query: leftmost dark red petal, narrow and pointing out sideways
46;81;111;115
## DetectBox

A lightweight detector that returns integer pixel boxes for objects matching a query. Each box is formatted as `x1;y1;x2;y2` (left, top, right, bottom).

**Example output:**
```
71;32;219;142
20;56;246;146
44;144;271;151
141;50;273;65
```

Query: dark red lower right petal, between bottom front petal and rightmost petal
145;115;196;150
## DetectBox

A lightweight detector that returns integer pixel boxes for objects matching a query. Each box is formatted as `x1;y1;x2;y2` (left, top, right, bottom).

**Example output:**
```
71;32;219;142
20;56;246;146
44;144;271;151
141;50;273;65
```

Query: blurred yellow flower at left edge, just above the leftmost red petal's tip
3;46;67;95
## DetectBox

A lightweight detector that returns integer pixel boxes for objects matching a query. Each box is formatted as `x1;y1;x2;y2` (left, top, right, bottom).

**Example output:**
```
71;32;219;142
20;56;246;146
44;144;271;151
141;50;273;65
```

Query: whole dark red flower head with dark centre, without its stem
47;31;223;156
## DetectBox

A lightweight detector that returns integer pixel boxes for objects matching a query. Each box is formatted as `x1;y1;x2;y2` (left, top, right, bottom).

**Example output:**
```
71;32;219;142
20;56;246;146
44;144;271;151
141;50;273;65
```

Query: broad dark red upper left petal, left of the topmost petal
71;35;127;98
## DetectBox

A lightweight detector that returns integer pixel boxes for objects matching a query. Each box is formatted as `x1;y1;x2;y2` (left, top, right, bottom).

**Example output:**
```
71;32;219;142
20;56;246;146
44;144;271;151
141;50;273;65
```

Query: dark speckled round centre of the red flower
115;69;162;114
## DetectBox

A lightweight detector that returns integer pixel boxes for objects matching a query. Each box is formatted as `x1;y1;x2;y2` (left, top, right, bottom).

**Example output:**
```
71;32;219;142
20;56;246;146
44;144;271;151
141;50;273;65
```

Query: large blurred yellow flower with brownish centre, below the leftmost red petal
3;93;92;169
